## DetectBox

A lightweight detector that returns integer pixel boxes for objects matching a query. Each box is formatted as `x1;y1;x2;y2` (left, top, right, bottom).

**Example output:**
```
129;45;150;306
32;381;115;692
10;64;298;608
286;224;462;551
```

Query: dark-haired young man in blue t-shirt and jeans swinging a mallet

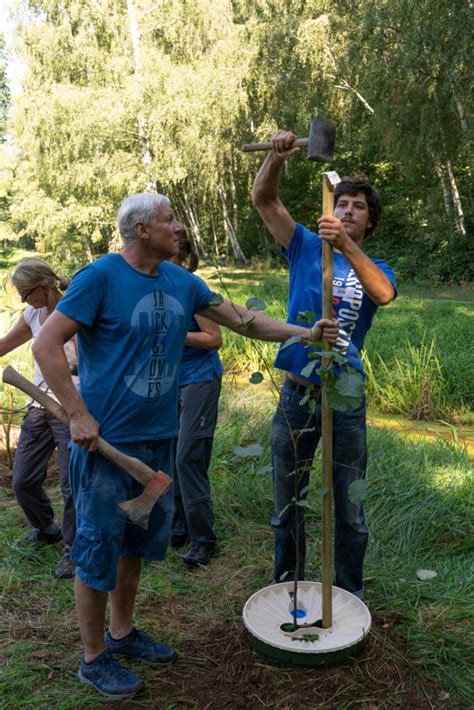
252;130;396;598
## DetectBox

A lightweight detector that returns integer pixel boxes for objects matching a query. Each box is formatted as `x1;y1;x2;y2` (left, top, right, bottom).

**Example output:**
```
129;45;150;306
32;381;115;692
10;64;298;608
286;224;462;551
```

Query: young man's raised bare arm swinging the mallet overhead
252;131;300;249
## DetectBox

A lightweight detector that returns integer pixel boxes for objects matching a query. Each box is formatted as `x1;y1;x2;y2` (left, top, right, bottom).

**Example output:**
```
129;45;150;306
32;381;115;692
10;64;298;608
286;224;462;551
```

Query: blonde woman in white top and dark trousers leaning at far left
0;257;79;579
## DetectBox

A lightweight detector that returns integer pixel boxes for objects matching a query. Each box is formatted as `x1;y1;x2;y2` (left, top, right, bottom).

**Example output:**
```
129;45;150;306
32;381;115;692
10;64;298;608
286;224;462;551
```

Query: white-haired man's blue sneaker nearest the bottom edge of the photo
77;650;144;700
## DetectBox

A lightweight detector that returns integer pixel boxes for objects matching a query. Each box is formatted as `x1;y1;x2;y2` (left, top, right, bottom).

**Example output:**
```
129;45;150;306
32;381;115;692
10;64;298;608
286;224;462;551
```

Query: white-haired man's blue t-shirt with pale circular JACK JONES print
57;254;213;443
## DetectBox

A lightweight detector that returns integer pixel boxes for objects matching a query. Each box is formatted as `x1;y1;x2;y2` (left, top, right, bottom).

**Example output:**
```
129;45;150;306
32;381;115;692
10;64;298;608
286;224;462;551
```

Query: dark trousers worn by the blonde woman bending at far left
12;407;76;545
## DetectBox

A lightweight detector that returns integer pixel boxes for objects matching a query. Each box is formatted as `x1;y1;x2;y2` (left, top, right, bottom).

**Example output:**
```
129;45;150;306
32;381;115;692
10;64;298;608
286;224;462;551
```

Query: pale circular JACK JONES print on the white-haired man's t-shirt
124;291;184;401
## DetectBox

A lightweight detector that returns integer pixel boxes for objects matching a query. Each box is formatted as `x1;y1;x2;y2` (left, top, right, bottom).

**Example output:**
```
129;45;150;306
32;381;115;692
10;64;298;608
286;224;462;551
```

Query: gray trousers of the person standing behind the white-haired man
171;377;221;546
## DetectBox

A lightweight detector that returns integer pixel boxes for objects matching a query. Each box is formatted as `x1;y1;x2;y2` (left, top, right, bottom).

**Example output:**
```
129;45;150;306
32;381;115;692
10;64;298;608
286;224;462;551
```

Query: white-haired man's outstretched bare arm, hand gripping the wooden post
201;301;339;343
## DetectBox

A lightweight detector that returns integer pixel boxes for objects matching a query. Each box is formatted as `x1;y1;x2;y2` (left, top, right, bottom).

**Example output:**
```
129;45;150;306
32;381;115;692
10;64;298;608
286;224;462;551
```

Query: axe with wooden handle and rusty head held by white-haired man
2;366;173;529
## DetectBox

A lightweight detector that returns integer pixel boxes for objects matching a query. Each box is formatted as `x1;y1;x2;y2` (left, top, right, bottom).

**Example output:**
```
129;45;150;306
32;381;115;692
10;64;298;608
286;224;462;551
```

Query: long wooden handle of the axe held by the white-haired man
2;366;173;493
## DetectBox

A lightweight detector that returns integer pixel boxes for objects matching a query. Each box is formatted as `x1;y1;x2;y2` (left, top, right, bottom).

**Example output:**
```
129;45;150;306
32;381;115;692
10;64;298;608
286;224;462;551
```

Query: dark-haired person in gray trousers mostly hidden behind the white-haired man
171;229;224;565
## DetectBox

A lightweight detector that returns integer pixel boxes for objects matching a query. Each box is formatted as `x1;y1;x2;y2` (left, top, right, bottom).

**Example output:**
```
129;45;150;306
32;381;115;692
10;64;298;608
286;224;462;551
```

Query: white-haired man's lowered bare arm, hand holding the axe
33;311;99;451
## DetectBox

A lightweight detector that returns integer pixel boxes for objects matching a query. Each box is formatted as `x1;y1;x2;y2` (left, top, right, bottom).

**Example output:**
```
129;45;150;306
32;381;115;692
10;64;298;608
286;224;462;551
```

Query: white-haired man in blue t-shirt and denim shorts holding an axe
33;194;338;698
